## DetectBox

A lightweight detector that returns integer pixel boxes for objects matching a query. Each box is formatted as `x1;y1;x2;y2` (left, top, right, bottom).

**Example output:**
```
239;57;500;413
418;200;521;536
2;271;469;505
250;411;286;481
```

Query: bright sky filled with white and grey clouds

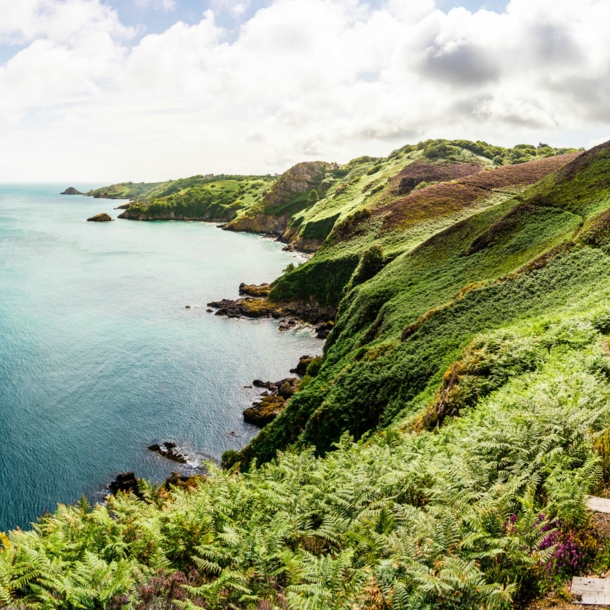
0;0;610;182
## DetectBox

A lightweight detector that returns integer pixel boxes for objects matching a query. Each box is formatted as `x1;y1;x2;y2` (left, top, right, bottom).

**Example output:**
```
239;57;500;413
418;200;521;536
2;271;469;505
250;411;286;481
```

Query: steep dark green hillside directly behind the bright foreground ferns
236;140;610;462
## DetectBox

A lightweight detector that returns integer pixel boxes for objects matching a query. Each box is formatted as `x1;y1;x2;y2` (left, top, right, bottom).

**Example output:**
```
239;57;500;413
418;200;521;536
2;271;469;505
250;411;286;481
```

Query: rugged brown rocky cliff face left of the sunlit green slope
225;161;333;237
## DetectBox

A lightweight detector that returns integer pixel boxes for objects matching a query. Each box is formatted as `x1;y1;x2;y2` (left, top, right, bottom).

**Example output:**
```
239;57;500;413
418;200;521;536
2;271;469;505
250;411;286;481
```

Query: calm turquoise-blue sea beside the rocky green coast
0;184;322;531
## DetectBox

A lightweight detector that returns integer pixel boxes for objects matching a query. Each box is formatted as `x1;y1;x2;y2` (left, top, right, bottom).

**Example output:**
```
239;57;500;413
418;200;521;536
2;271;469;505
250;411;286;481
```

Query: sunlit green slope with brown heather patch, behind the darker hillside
271;142;571;306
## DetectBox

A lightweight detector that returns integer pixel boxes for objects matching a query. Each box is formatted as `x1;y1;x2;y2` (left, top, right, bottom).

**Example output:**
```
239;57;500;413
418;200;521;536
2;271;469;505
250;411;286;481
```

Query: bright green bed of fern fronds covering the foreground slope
0;312;610;610
